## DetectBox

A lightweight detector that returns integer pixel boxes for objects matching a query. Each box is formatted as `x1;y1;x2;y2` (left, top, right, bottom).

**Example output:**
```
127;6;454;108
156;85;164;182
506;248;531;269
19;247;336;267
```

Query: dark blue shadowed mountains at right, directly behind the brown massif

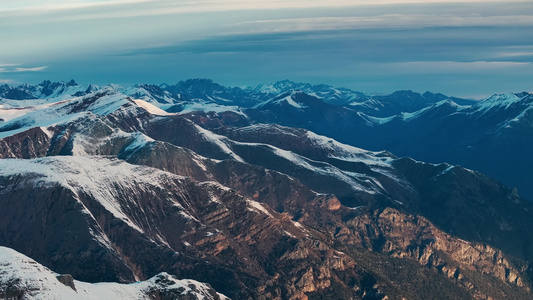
244;92;533;200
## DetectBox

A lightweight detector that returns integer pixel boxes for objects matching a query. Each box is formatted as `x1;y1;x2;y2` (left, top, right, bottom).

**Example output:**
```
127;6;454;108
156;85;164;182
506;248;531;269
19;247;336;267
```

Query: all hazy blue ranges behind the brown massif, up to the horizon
0;79;533;200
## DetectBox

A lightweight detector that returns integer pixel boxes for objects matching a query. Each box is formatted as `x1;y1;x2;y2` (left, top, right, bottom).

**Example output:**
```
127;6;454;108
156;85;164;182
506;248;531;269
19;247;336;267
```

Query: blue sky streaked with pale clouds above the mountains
0;0;533;98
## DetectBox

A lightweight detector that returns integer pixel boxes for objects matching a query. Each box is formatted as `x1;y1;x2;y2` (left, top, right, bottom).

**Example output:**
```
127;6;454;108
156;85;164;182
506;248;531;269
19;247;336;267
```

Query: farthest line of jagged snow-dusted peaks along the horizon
0;79;476;110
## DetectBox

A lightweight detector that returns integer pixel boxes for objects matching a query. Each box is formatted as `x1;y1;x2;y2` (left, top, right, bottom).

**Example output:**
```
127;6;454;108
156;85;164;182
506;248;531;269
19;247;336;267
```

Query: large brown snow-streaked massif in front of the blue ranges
0;91;533;299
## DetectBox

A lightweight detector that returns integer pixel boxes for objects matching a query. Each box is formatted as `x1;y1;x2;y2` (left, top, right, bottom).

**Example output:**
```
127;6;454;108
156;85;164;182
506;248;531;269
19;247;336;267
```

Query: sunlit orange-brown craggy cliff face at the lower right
336;208;530;299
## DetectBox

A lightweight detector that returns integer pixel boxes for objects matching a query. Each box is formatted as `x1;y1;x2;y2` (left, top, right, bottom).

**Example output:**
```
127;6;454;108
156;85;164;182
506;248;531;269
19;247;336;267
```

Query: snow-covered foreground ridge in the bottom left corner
0;247;229;300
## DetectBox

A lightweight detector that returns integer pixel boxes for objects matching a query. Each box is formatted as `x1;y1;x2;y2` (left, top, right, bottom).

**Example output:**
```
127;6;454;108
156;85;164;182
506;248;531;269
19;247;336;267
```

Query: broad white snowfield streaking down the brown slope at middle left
0;156;183;232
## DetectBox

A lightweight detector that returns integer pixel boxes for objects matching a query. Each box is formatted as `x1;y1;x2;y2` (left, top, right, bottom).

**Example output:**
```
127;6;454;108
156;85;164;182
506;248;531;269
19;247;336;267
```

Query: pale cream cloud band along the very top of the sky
0;0;530;22
